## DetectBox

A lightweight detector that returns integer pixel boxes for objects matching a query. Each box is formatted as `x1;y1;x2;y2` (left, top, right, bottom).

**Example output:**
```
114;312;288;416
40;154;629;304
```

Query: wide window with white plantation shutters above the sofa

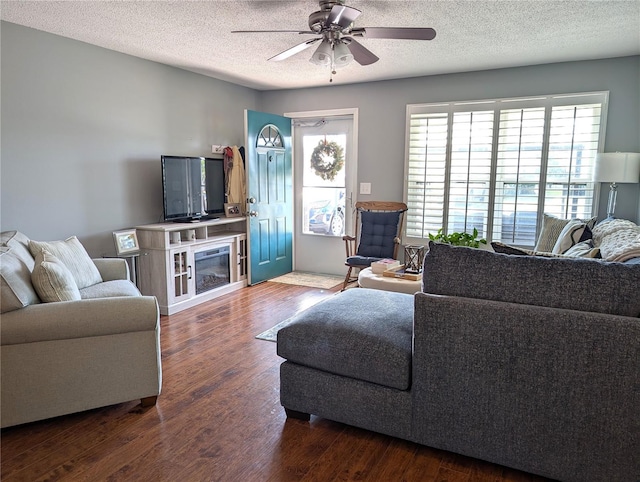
405;92;608;247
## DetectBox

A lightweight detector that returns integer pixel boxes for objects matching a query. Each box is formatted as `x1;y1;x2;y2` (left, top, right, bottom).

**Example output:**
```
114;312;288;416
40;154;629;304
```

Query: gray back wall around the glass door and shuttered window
262;56;640;221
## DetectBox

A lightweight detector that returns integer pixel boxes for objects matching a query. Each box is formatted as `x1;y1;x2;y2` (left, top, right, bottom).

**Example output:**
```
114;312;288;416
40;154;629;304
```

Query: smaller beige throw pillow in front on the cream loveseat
31;251;80;303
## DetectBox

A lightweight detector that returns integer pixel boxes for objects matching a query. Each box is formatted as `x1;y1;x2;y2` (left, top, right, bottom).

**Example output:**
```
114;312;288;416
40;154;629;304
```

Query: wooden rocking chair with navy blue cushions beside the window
342;201;407;291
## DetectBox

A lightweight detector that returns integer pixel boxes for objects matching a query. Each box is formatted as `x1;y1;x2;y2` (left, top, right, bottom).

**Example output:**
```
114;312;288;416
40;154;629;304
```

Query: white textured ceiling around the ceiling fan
0;0;640;90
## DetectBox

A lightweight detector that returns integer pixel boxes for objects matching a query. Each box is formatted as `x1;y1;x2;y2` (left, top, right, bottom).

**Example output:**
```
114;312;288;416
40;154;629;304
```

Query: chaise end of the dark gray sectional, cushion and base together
277;288;413;437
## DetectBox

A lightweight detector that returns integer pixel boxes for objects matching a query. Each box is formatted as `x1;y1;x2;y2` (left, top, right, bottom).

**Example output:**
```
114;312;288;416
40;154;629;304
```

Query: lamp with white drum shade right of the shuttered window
595;152;640;218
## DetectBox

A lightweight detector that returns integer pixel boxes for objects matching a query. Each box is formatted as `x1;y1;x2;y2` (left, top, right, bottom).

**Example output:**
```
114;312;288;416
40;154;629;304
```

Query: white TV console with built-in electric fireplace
136;217;247;315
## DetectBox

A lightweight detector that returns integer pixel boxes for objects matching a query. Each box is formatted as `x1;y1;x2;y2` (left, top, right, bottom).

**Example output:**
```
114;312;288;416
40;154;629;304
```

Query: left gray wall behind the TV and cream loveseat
0;22;260;256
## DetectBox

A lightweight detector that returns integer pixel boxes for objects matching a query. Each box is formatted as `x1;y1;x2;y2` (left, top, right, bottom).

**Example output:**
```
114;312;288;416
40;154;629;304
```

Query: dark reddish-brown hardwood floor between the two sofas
1;282;543;482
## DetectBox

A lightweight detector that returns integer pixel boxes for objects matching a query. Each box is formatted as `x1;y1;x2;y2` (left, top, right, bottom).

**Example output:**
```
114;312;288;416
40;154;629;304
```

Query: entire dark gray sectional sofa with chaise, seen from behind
277;243;640;482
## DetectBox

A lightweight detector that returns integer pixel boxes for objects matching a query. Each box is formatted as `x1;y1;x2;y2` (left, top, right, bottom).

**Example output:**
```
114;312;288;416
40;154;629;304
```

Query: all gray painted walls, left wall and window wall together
0;22;640;256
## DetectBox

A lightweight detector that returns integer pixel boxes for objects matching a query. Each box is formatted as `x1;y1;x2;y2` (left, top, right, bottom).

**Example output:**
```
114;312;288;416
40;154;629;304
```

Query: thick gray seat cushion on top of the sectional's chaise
278;288;413;390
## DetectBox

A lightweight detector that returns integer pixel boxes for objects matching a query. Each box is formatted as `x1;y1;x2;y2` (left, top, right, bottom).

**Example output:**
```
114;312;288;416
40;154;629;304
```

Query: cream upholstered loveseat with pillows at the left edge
0;231;162;427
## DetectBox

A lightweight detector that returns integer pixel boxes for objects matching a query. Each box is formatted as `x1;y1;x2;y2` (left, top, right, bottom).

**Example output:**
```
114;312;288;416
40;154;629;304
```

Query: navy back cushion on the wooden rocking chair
356;211;401;258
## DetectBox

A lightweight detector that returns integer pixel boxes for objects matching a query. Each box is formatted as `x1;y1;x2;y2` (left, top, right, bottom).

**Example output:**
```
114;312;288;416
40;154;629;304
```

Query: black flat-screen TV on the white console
161;156;225;222
